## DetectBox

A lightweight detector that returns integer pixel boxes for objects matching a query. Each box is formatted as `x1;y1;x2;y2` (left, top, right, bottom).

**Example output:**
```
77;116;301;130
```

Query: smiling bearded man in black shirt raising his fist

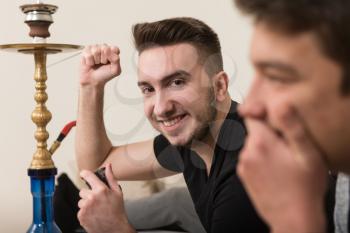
76;18;268;233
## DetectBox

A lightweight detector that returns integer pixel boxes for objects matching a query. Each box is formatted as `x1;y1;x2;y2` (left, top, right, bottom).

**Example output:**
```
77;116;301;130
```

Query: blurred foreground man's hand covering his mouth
238;105;327;232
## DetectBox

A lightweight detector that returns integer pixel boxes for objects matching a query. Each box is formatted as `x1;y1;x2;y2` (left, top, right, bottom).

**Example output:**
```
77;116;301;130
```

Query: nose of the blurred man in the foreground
239;77;268;118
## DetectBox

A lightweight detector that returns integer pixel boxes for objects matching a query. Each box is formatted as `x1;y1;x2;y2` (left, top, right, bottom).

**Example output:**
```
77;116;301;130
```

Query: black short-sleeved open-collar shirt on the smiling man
154;101;269;233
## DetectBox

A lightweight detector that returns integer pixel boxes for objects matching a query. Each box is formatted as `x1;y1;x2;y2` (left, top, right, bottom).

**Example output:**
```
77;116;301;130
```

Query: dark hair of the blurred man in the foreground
235;0;350;94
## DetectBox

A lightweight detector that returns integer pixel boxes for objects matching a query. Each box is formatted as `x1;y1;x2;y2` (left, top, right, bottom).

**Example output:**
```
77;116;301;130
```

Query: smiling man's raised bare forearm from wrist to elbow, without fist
75;85;112;169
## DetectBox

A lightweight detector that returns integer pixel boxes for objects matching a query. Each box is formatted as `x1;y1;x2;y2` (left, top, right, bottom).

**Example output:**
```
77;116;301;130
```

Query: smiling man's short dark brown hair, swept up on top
132;17;223;76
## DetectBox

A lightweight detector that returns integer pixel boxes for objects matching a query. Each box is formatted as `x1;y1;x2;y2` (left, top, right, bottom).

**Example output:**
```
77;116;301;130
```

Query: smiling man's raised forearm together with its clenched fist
75;45;121;170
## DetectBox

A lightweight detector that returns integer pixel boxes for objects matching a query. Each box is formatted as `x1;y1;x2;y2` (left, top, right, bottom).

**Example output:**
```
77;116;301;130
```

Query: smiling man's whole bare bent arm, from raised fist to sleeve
75;45;174;180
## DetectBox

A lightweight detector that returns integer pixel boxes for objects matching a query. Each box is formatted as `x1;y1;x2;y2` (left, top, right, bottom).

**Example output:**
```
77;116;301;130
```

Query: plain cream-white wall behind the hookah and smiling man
0;0;252;232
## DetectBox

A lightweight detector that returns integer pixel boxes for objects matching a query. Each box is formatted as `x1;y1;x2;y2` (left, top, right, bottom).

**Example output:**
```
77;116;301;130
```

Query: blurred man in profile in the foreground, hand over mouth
235;0;350;233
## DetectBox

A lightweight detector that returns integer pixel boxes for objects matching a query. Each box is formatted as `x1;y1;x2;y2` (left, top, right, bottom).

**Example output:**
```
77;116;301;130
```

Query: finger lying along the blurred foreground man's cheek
277;105;326;163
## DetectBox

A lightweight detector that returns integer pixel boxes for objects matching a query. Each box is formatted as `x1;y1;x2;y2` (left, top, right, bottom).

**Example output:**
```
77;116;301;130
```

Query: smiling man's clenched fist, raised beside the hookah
80;44;121;86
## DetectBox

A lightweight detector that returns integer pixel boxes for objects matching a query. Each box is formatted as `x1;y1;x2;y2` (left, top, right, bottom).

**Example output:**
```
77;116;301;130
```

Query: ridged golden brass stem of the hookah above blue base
30;50;55;169
